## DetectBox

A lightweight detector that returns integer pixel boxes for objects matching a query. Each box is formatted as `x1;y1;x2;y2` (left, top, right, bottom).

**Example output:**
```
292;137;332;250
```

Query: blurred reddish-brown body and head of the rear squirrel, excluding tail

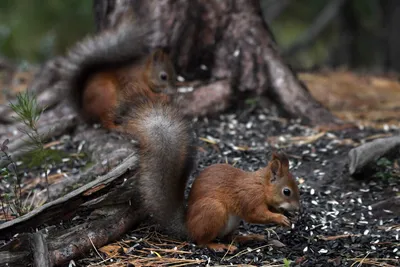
82;50;175;129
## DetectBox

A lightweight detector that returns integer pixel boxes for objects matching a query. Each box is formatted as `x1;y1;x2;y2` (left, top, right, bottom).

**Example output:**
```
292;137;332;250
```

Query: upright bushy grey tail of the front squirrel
123;98;196;239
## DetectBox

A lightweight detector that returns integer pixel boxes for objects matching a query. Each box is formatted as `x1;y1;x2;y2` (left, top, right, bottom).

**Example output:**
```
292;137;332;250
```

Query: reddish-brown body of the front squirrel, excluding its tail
186;152;300;251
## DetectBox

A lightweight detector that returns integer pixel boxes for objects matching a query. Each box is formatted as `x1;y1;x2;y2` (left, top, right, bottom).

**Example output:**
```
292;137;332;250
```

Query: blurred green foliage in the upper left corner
0;0;93;63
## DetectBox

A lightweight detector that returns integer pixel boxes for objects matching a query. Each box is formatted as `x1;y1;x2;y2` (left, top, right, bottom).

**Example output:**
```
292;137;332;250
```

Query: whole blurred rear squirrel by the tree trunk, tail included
61;23;176;129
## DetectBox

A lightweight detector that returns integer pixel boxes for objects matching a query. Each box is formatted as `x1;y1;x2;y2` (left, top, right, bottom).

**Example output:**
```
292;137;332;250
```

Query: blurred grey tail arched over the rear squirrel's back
60;23;153;115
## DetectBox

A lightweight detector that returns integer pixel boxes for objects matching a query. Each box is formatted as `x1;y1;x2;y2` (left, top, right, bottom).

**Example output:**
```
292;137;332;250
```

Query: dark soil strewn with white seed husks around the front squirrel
74;101;400;266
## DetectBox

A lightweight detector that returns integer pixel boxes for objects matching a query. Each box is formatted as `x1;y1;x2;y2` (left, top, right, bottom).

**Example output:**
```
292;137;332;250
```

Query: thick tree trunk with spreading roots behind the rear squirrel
94;0;339;124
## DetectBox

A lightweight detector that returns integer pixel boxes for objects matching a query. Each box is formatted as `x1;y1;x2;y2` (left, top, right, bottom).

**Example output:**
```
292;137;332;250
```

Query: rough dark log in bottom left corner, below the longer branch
0;205;142;267
